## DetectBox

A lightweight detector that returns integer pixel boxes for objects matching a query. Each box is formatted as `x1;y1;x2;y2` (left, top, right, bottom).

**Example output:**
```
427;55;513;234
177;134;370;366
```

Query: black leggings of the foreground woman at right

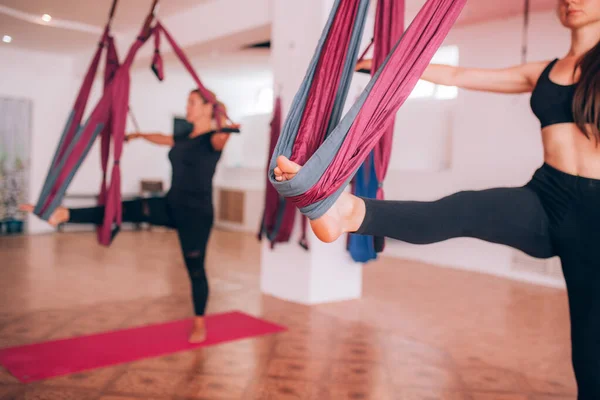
356;164;600;400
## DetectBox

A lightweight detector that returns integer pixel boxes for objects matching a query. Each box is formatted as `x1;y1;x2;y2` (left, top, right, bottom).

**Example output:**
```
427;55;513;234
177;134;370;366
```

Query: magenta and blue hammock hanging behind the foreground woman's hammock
348;0;405;263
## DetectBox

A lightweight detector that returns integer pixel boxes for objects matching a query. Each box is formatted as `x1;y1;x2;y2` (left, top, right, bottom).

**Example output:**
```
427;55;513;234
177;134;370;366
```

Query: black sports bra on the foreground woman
530;58;577;128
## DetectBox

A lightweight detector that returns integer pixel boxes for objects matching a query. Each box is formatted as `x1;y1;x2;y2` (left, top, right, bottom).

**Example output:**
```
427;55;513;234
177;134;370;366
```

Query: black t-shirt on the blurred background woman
168;131;221;207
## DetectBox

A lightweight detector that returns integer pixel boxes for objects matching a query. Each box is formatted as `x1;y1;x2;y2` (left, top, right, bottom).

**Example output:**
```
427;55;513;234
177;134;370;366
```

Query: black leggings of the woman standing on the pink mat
69;195;214;316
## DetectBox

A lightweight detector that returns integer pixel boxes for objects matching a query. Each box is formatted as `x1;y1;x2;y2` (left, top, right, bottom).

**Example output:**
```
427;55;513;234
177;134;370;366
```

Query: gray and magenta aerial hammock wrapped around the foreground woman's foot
268;0;466;219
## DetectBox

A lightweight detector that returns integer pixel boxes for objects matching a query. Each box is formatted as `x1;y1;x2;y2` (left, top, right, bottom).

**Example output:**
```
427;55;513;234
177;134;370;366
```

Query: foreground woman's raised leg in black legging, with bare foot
274;157;554;258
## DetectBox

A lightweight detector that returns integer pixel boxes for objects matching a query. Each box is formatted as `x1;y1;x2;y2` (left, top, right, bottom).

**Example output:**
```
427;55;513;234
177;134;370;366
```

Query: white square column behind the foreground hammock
261;0;371;304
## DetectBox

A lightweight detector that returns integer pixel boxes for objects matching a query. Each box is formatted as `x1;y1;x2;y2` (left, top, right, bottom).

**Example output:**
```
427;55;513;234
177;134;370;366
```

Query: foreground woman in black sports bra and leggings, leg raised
274;0;600;400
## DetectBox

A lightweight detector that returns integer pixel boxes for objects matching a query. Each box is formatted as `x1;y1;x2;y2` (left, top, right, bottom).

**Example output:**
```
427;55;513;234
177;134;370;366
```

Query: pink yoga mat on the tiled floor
0;311;286;383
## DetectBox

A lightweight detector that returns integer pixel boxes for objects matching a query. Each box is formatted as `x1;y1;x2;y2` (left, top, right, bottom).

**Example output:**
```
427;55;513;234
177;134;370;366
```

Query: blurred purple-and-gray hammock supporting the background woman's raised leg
35;9;156;245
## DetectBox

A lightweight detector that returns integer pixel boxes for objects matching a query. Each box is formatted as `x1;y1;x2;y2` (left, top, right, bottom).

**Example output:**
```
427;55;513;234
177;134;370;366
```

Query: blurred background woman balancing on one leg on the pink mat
21;90;238;343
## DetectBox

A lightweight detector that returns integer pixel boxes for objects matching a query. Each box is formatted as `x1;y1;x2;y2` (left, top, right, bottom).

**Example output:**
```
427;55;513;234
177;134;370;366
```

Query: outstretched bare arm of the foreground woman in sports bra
356;59;548;93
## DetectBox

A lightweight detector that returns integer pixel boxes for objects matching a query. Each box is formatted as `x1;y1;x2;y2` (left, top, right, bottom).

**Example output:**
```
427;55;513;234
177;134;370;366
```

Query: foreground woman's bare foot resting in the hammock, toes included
273;156;365;243
